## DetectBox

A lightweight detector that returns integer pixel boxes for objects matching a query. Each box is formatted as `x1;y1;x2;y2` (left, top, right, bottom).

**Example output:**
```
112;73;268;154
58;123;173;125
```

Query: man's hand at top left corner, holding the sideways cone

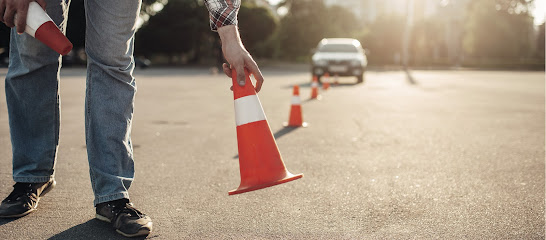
0;0;46;33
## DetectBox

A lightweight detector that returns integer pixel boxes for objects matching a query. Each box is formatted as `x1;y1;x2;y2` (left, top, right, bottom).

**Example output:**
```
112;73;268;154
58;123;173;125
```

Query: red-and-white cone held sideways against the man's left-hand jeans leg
20;2;72;55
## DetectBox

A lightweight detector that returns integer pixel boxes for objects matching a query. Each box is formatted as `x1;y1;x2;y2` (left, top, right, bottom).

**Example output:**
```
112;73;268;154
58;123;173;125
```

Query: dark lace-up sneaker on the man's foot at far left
0;179;56;218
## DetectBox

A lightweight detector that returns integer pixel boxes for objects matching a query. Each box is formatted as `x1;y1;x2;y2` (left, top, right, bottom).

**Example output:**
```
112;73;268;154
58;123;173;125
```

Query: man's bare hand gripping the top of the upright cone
218;25;264;92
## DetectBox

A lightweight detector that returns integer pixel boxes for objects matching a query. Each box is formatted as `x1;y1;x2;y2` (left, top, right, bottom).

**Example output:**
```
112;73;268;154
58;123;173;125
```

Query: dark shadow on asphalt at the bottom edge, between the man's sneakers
49;219;154;240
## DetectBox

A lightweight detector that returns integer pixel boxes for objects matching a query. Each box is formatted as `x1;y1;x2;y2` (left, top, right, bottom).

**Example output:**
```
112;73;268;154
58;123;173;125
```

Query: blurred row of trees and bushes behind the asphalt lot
56;0;544;65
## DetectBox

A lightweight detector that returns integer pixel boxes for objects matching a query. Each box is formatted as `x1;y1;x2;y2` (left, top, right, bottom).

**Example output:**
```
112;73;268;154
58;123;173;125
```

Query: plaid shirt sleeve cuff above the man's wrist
205;0;241;31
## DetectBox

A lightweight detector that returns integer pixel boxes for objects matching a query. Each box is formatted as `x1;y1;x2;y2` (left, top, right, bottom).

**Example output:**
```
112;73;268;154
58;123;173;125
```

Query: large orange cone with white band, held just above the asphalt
228;69;303;195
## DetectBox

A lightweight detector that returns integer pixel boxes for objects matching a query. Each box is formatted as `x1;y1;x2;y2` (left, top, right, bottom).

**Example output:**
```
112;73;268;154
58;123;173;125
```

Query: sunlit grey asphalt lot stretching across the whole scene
0;69;545;239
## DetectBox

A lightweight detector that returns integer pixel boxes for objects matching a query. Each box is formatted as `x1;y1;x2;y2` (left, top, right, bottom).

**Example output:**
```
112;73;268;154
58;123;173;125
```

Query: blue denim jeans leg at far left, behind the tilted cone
5;0;69;182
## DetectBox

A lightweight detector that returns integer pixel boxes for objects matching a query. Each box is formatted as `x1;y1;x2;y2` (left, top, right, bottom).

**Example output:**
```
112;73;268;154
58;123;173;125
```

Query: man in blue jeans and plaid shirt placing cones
0;0;263;237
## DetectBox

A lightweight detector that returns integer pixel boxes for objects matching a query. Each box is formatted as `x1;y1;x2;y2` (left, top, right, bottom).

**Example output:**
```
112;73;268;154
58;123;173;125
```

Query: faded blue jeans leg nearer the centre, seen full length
84;0;140;205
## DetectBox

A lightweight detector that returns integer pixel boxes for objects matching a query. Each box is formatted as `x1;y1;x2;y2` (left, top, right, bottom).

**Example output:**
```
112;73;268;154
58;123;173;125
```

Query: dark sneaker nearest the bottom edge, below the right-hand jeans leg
95;198;152;237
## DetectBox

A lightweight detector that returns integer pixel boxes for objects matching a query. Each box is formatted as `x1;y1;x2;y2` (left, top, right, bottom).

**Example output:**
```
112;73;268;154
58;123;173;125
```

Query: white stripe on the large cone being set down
235;95;266;127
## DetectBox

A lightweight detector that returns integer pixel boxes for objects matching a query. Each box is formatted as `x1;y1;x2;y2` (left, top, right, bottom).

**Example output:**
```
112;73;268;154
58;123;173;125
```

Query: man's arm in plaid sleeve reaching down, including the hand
205;0;264;92
